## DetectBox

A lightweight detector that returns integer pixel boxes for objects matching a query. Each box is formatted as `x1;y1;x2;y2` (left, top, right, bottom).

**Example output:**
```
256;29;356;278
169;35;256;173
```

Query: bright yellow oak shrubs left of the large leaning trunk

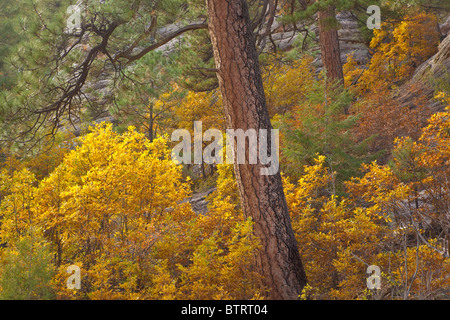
0;125;261;299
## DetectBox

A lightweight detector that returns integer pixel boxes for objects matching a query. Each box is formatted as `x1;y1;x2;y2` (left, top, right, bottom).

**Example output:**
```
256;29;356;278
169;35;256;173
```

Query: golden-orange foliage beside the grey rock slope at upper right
343;13;439;94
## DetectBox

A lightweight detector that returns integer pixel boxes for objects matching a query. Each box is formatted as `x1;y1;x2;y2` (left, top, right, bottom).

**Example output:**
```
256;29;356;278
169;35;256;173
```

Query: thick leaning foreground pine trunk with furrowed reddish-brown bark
206;0;306;299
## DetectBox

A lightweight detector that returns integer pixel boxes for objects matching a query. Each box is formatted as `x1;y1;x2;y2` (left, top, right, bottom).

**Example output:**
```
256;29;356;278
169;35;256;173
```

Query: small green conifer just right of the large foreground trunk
276;67;371;189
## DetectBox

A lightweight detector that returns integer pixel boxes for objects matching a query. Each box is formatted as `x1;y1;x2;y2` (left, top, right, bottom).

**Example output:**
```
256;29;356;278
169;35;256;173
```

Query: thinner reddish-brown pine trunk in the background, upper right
317;6;344;85
